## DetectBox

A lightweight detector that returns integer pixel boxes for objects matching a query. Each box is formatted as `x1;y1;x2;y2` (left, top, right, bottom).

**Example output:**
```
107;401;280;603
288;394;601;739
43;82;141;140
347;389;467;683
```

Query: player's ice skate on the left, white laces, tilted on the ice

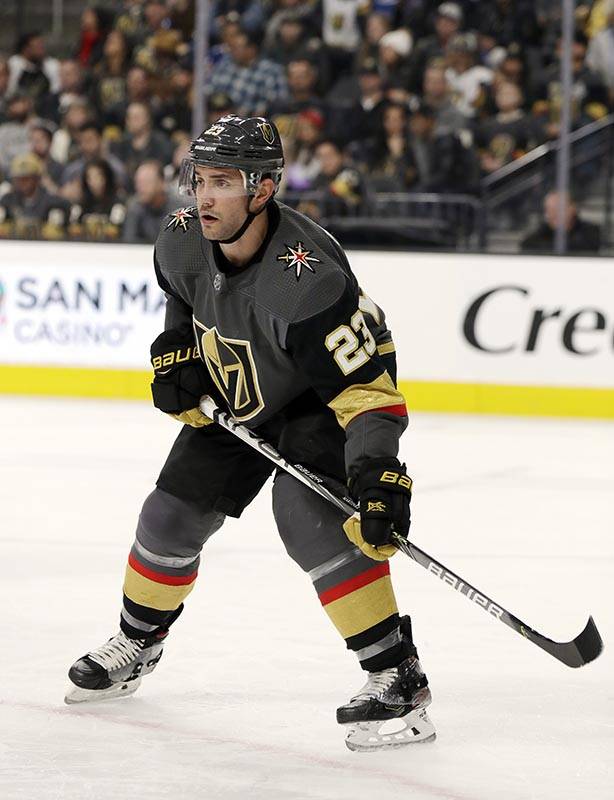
64;630;168;704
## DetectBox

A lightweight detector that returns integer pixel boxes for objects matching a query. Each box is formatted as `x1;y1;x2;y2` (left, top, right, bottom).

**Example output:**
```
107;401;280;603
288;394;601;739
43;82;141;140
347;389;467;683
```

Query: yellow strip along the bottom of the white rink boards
0;364;614;419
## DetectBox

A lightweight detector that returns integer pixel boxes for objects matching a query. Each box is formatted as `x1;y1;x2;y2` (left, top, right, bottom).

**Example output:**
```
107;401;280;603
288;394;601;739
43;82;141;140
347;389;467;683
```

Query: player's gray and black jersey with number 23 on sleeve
155;201;407;482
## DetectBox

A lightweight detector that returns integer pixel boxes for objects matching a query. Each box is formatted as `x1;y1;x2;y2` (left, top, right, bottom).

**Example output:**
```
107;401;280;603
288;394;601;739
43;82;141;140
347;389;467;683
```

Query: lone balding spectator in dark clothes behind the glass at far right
521;192;601;253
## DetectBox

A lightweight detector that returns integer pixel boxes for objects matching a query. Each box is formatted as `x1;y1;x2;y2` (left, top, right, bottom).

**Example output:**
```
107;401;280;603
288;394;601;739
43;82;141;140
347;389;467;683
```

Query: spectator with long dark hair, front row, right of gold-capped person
70;158;126;242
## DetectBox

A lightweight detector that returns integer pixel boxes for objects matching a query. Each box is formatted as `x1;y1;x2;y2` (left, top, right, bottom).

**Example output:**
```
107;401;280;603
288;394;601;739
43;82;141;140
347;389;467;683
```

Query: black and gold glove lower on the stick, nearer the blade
343;458;412;561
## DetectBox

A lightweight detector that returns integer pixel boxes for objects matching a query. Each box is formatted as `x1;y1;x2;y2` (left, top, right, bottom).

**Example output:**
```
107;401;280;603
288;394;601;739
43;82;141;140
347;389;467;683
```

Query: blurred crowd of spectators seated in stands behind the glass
0;0;614;250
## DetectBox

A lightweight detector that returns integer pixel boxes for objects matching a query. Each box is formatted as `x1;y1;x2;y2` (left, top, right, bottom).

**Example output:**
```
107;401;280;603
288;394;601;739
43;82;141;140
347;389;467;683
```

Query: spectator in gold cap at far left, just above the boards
0;153;70;239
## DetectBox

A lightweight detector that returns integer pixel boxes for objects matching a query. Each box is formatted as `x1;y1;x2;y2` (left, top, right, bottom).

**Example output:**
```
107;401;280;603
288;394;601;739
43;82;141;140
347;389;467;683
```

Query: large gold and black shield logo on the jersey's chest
194;318;264;421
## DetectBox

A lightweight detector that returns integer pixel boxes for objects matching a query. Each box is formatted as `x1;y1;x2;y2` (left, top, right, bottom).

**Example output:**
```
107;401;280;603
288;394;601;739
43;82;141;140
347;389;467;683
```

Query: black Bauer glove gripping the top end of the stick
151;323;213;428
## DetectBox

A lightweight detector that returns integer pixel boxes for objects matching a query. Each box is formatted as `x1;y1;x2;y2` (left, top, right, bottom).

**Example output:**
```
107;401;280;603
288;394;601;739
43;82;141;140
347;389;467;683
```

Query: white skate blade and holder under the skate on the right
345;709;437;752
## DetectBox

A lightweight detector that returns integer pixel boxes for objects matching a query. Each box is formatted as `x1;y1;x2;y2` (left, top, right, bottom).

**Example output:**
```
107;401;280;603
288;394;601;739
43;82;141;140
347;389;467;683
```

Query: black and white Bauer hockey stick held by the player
200;396;603;667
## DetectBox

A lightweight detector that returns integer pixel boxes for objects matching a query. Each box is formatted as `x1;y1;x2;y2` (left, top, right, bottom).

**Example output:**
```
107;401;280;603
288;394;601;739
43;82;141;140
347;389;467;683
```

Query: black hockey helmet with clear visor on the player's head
179;114;284;195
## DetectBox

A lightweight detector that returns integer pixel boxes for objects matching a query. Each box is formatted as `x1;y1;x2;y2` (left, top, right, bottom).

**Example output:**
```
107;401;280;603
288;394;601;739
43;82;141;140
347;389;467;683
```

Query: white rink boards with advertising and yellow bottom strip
0;242;614;418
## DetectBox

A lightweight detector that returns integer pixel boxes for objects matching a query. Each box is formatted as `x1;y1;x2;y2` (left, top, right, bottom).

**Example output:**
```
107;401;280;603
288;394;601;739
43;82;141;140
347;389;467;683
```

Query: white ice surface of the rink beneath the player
0;397;614;800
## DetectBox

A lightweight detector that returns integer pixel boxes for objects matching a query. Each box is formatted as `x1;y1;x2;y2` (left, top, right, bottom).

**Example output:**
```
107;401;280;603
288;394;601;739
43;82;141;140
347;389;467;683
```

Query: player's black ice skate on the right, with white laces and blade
337;617;436;751
